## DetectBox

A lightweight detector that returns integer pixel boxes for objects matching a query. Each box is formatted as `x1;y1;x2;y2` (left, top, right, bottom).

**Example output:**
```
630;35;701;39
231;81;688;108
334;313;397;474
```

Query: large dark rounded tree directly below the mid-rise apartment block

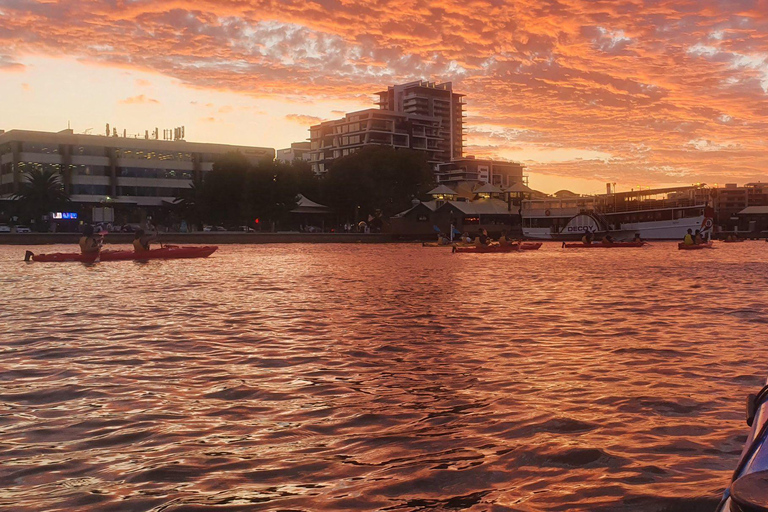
322;146;434;220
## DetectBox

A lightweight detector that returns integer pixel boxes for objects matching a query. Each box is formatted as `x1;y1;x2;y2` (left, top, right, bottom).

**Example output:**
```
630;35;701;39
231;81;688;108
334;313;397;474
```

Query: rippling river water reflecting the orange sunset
0;242;768;511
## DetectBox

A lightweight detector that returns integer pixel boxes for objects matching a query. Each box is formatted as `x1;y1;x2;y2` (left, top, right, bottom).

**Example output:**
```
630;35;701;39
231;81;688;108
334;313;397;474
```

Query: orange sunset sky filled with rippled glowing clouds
0;0;768;193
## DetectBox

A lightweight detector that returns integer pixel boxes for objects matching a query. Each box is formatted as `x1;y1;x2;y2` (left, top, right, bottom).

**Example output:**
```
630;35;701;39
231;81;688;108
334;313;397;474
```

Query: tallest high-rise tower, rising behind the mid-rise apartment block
376;80;465;162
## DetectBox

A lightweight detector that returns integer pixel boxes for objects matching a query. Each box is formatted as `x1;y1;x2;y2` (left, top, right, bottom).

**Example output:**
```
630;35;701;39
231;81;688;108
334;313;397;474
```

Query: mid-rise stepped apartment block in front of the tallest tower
309;108;443;174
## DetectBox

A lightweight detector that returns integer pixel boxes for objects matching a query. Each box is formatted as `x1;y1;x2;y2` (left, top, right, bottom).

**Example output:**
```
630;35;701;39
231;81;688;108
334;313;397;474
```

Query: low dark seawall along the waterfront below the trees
0;231;396;245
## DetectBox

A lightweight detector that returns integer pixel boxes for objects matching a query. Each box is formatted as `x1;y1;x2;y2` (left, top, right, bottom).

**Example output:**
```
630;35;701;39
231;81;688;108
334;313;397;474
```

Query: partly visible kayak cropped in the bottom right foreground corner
716;376;768;512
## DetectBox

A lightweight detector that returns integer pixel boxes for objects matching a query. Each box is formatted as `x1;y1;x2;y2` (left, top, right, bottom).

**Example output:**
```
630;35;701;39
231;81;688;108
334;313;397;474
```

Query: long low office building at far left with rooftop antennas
0;130;275;206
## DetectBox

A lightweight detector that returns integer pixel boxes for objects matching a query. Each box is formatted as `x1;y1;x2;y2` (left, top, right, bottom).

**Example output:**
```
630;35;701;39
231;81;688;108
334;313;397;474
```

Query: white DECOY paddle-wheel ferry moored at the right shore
520;185;714;240
